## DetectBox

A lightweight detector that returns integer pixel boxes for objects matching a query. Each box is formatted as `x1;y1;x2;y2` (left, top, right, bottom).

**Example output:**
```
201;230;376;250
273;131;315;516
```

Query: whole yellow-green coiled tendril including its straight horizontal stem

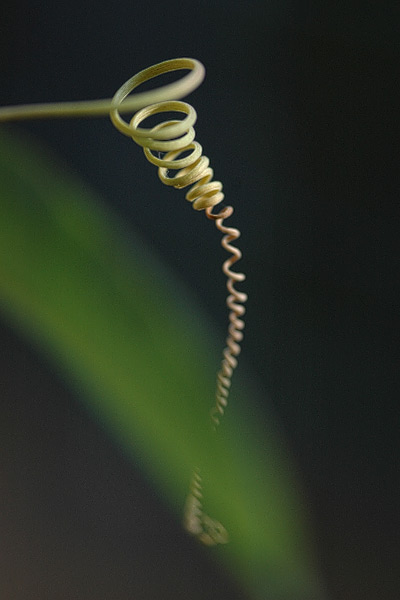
0;58;247;545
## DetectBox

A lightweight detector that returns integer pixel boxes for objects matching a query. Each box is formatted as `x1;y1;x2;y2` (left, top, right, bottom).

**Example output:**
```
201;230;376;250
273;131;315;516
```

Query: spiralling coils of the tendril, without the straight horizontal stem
110;59;247;545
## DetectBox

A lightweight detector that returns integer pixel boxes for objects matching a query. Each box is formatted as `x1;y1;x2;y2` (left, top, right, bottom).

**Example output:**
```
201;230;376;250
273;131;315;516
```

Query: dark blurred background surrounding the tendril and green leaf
0;0;400;600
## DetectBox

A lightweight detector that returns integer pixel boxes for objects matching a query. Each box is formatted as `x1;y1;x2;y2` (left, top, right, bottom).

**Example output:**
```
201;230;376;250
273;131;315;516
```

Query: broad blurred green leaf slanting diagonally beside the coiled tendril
0;133;322;600
